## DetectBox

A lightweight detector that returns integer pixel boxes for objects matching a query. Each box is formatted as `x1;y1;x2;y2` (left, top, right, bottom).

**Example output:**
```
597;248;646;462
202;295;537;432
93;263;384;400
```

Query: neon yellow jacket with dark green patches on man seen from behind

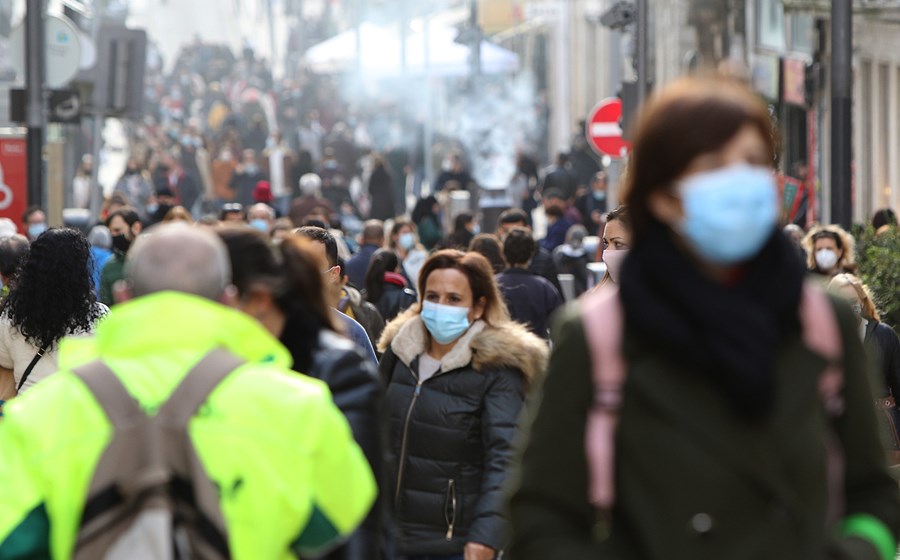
0;292;376;560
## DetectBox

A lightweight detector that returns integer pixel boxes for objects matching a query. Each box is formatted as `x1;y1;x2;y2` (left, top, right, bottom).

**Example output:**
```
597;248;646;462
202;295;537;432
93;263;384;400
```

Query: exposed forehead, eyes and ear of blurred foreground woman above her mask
649;124;772;227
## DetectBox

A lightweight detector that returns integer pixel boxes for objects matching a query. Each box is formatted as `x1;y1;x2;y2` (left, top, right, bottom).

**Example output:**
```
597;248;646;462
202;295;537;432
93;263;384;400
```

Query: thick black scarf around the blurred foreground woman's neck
621;223;804;418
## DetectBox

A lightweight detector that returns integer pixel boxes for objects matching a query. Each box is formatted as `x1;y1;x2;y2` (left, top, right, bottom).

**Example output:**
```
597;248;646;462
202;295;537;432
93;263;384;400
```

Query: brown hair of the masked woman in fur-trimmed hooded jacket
417;249;510;325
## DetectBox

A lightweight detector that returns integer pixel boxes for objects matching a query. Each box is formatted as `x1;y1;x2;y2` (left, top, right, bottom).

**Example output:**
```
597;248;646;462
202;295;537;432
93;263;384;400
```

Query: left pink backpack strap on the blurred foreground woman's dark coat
581;288;625;510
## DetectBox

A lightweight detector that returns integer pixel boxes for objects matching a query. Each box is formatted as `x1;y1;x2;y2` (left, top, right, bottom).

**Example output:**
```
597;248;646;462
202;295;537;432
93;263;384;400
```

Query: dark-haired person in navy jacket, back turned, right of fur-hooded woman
497;228;563;338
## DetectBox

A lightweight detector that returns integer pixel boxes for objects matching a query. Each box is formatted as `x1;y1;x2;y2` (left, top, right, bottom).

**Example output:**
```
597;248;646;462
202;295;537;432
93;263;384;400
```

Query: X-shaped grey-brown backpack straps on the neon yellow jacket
73;349;244;558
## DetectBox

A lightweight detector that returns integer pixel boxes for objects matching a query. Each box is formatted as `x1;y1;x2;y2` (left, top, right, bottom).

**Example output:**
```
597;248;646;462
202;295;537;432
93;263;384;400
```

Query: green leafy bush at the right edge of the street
856;227;900;329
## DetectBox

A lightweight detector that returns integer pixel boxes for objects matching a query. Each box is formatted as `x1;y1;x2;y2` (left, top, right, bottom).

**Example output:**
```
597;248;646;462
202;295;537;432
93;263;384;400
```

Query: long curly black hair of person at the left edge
0;228;103;349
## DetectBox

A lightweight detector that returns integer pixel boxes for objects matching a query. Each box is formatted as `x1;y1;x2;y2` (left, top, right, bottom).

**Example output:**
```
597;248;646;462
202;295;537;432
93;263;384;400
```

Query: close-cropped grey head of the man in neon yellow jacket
125;222;231;300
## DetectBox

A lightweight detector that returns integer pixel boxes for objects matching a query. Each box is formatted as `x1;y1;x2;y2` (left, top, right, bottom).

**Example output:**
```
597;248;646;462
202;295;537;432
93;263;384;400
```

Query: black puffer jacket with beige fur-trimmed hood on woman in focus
380;310;547;555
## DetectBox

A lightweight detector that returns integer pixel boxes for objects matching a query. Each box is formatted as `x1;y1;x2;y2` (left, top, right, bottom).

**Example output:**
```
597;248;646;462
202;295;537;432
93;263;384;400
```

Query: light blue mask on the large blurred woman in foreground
676;163;778;265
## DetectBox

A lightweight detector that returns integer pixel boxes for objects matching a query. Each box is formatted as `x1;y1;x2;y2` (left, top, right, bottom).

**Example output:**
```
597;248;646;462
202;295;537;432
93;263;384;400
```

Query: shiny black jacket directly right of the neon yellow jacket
281;331;384;560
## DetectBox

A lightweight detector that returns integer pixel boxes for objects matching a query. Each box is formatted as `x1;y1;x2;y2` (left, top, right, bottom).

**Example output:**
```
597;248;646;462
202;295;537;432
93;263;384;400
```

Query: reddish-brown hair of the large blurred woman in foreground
625;78;776;241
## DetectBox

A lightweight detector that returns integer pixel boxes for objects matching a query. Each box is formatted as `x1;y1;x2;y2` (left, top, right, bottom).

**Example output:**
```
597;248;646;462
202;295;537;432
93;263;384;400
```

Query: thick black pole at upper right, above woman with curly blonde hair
831;0;853;229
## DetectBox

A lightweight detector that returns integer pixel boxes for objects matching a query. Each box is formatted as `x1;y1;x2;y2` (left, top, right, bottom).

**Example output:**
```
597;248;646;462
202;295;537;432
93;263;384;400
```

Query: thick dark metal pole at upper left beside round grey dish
25;0;46;207
